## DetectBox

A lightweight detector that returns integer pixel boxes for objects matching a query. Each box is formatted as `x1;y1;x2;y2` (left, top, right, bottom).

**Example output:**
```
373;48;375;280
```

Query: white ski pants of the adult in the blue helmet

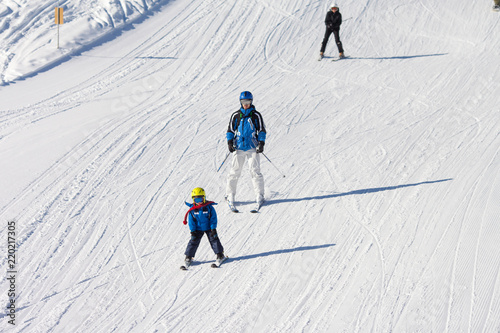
226;149;264;201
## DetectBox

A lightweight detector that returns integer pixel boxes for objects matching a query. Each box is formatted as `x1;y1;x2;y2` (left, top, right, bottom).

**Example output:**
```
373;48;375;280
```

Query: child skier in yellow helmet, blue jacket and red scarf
181;187;225;269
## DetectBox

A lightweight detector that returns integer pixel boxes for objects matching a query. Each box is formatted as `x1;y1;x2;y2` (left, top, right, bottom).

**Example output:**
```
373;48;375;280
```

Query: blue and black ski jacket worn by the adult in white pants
226;105;266;151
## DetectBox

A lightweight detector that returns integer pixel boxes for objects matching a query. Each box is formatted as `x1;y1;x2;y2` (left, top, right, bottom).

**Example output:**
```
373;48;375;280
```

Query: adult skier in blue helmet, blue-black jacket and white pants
226;91;266;212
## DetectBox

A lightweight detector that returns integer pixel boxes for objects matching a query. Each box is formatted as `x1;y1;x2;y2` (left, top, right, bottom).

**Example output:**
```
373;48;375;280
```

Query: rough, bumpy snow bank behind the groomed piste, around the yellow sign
0;0;176;84
